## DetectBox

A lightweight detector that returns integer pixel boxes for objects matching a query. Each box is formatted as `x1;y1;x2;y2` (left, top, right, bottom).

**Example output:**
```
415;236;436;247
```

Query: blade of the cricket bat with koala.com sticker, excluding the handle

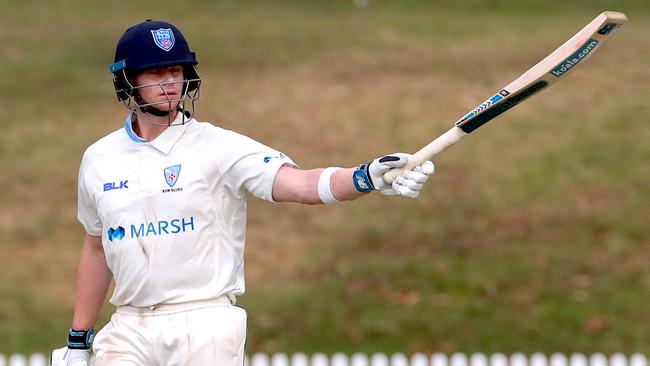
456;12;627;133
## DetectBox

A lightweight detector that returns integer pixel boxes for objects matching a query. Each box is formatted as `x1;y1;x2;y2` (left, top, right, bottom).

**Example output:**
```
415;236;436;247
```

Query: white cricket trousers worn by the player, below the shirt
93;296;246;366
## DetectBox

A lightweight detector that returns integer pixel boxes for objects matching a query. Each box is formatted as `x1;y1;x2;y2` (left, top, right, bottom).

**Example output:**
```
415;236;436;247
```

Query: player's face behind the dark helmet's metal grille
133;66;184;111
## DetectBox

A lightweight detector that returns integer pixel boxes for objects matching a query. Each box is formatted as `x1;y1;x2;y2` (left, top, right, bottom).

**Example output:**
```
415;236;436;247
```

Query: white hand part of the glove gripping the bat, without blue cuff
368;153;435;198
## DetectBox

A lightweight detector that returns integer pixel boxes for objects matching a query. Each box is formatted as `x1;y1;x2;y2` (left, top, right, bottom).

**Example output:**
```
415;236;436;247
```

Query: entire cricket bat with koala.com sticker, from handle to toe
384;11;627;183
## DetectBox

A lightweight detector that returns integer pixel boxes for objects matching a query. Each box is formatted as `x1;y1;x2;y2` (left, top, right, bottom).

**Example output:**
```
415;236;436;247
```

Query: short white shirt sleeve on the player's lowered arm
77;153;102;236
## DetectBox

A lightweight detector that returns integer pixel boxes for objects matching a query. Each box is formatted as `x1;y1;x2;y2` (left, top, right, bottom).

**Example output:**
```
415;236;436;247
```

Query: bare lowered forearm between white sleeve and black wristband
72;235;111;329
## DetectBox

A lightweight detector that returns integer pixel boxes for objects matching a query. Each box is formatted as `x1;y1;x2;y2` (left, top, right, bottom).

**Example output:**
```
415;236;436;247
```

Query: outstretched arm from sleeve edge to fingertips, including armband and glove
273;153;434;204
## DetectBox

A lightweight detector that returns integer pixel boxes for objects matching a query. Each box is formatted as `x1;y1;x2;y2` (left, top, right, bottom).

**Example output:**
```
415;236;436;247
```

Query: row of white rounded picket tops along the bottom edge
0;353;650;366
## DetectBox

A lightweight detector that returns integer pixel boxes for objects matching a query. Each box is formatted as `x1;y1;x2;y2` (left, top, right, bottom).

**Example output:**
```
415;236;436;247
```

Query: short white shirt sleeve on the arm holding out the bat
220;136;297;202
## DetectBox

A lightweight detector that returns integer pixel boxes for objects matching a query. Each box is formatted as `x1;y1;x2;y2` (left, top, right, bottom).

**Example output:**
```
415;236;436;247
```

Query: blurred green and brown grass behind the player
0;0;650;354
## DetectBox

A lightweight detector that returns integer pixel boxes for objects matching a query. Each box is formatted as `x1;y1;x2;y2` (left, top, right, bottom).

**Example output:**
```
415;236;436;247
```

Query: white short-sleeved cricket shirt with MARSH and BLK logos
78;113;295;307
